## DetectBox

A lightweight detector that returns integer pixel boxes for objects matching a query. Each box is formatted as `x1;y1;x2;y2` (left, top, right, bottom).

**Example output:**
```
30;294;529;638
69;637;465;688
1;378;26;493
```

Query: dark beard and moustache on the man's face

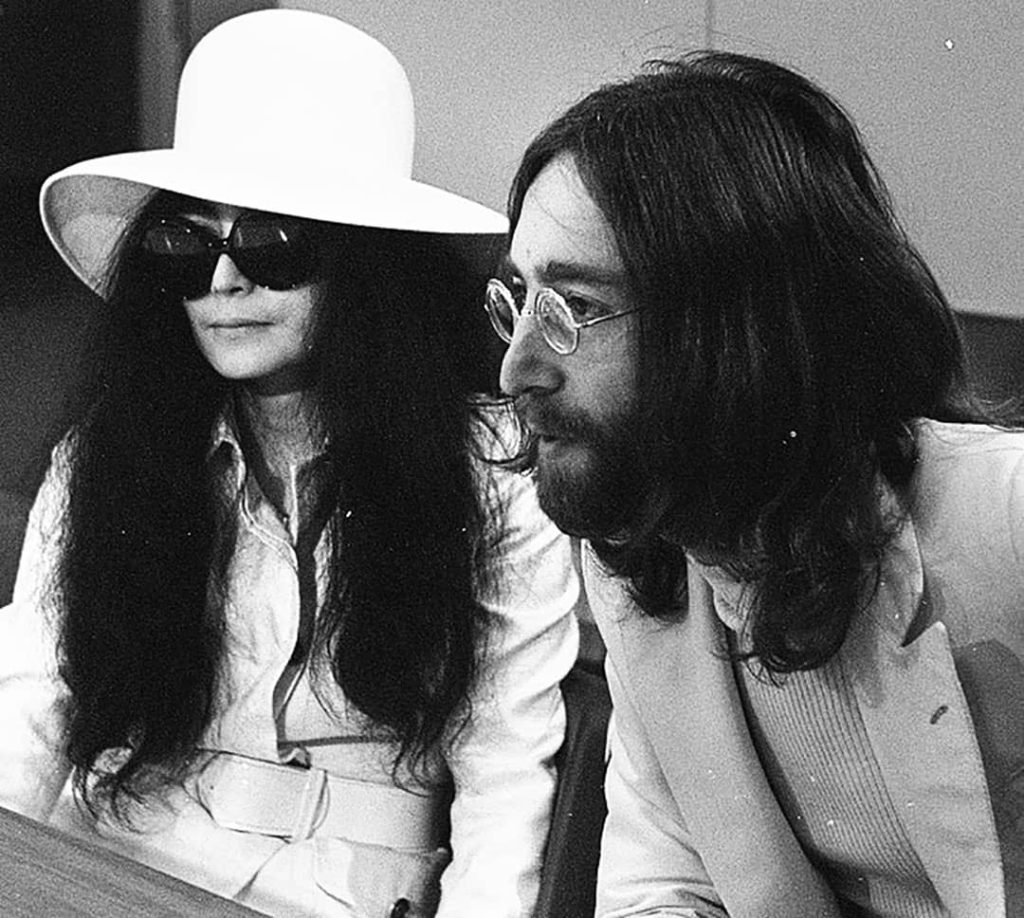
527;395;641;539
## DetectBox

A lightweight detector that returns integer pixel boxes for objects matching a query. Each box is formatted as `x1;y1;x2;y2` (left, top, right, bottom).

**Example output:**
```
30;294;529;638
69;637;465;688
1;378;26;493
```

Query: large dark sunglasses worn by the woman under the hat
141;213;319;299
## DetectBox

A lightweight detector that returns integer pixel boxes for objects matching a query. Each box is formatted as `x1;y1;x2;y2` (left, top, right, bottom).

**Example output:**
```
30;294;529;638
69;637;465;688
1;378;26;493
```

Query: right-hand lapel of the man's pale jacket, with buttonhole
842;523;1005;918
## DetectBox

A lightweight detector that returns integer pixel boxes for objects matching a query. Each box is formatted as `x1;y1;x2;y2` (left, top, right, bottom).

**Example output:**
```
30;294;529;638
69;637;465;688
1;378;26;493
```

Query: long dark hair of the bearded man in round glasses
509;52;995;672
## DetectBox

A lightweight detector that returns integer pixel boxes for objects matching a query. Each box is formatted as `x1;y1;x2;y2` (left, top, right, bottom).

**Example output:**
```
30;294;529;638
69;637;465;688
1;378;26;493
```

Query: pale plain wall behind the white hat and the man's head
142;0;1024;317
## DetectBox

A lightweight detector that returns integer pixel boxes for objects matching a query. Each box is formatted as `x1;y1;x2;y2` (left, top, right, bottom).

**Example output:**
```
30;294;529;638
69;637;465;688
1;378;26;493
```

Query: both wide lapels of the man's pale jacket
588;512;1005;918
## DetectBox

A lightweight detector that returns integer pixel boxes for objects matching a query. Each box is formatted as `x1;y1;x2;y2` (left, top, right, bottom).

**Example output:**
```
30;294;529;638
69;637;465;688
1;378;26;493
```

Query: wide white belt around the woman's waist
196;752;445;849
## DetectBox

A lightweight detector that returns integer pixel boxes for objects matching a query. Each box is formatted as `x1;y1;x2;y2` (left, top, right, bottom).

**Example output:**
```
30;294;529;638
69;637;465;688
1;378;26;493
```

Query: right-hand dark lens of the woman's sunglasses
229;214;317;290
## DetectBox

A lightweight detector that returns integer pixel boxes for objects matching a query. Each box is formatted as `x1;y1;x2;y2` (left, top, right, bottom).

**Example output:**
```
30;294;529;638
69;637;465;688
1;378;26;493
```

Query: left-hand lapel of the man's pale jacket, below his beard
591;549;840;918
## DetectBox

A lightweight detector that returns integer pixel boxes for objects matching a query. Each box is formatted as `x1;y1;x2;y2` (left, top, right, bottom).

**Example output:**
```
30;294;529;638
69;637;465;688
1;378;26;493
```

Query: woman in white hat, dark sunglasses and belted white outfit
0;10;578;916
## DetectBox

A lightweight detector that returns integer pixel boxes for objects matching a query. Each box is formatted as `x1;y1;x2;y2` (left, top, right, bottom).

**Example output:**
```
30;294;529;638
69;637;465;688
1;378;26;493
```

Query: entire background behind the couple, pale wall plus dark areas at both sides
0;0;1024;493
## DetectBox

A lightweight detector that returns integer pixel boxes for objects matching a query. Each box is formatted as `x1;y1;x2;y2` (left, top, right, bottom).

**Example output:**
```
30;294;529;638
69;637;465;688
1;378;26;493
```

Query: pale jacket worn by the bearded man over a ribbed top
584;422;1024;918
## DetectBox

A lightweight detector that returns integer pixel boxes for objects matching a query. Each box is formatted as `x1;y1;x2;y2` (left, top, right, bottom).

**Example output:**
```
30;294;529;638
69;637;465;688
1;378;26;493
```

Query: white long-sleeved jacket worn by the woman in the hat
0;413;579;918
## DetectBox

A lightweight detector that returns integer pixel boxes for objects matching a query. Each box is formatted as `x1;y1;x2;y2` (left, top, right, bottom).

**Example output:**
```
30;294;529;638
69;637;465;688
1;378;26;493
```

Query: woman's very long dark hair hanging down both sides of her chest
55;193;503;808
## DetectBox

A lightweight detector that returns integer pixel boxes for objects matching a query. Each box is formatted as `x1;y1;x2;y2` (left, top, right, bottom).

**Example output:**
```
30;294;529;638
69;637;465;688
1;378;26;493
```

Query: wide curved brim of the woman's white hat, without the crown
40;150;508;294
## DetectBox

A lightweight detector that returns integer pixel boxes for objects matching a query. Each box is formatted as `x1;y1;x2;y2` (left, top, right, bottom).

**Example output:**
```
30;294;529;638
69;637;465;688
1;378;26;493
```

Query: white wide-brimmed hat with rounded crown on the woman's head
40;9;508;293
